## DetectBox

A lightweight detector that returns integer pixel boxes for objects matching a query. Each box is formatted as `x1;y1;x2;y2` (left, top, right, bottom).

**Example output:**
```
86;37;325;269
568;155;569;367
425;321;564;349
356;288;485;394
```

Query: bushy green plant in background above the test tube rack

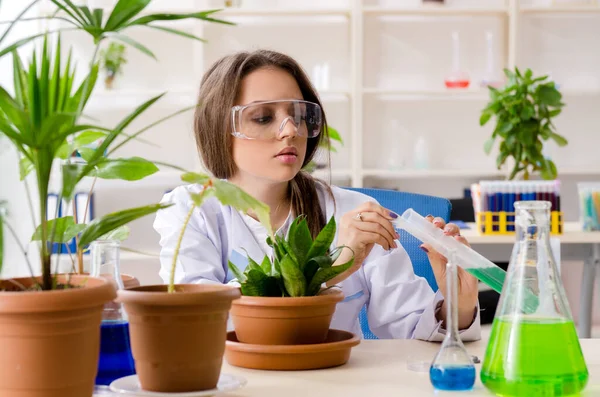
479;68;568;179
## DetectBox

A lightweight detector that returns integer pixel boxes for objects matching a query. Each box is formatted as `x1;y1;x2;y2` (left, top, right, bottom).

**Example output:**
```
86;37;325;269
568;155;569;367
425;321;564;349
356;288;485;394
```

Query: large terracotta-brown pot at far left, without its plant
0;275;116;397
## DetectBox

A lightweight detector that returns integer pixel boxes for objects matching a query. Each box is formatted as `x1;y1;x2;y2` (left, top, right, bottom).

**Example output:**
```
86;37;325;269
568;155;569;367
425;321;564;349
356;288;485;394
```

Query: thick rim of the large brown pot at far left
0;274;117;313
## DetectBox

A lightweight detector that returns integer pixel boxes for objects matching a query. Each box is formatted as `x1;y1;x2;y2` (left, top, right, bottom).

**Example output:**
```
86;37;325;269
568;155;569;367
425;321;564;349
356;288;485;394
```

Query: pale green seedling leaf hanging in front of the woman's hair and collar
212;179;273;235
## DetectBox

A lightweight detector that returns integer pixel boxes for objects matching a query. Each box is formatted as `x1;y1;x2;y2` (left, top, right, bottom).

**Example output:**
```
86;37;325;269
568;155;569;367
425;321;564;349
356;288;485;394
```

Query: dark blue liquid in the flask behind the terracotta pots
96;321;135;385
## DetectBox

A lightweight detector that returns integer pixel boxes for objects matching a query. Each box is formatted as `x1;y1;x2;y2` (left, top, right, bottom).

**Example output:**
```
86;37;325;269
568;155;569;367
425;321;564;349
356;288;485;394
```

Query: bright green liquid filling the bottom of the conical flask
481;318;588;397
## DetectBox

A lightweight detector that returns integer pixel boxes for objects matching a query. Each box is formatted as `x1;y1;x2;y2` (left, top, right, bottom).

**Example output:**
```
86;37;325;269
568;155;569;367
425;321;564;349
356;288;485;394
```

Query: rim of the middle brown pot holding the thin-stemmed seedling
116;284;241;306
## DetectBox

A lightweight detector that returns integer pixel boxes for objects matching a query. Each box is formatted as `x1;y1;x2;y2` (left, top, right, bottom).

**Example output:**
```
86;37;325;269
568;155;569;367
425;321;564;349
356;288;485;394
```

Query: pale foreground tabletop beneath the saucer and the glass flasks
223;339;600;397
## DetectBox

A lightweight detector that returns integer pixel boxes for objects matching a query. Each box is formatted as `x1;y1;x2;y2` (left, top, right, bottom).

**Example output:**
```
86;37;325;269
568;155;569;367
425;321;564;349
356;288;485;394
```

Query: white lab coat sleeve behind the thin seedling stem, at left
154;187;230;284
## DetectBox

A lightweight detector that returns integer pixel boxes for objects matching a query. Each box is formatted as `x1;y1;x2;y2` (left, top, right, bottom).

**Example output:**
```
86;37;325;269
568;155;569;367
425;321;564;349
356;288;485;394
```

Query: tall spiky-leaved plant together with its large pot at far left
0;0;234;397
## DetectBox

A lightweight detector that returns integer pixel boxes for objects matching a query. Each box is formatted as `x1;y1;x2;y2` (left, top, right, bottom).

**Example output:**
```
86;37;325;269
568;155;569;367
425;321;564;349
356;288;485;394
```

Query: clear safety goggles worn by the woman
231;99;323;140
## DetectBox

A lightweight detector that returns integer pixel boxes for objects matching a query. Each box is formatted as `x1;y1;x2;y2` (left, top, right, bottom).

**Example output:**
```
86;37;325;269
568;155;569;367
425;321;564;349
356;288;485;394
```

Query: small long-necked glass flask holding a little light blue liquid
429;252;476;391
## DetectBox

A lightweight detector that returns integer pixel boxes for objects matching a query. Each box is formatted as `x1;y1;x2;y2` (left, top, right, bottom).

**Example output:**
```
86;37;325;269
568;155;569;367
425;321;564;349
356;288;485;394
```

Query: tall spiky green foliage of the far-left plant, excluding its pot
0;0;237;290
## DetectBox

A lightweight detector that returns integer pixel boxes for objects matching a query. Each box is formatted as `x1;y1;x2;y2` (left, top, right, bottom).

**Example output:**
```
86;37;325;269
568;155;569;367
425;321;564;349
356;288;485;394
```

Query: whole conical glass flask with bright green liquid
480;201;588;397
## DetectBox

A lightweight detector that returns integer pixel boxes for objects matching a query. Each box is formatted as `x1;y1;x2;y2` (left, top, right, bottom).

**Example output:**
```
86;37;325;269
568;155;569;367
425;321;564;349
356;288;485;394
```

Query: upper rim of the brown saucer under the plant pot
225;328;360;354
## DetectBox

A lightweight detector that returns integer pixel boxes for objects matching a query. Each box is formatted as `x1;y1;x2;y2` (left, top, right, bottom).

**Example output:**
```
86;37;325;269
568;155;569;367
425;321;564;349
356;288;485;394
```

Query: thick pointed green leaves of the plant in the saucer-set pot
229;216;354;297
